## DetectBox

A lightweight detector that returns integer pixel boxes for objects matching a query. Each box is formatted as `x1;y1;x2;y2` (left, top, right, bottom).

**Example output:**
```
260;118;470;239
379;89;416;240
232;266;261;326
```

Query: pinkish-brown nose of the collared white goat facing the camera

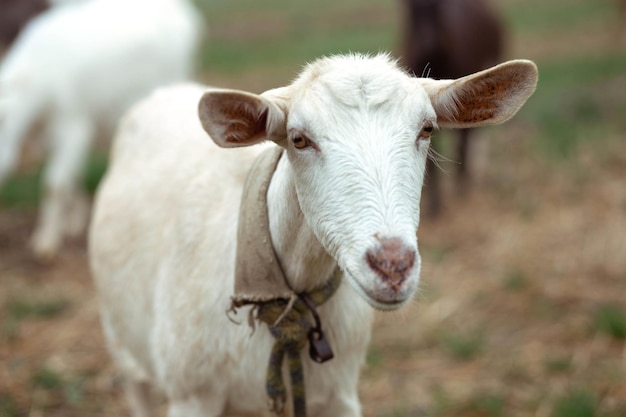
366;237;416;290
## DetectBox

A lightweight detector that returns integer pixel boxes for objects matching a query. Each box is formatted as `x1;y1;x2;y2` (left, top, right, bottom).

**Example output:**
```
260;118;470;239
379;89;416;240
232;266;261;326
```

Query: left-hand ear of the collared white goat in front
198;90;286;148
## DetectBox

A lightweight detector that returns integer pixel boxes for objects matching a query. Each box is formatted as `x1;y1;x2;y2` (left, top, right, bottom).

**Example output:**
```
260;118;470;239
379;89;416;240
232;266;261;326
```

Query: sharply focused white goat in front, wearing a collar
89;55;537;417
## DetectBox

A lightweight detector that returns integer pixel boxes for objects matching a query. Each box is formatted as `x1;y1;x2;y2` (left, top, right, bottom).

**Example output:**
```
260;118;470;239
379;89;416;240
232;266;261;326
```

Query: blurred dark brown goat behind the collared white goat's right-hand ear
402;0;503;216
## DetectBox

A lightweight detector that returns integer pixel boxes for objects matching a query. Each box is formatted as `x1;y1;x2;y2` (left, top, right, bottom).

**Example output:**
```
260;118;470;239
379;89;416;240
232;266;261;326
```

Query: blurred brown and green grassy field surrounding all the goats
0;0;626;417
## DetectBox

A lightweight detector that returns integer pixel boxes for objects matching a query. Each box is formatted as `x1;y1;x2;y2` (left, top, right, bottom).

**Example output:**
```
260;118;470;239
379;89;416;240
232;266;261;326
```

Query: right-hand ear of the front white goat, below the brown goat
419;60;538;128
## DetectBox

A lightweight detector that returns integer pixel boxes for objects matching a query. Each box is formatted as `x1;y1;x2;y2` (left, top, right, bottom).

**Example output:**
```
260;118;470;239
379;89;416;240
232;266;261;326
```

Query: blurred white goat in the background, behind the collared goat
0;0;202;258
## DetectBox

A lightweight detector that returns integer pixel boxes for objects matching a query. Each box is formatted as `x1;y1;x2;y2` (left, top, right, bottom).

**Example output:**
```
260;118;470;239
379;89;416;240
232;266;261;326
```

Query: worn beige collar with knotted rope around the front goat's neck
229;146;342;417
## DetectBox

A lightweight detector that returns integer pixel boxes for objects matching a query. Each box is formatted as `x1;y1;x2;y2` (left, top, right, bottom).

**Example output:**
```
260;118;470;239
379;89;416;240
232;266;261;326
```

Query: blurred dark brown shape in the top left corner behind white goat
0;0;49;51
